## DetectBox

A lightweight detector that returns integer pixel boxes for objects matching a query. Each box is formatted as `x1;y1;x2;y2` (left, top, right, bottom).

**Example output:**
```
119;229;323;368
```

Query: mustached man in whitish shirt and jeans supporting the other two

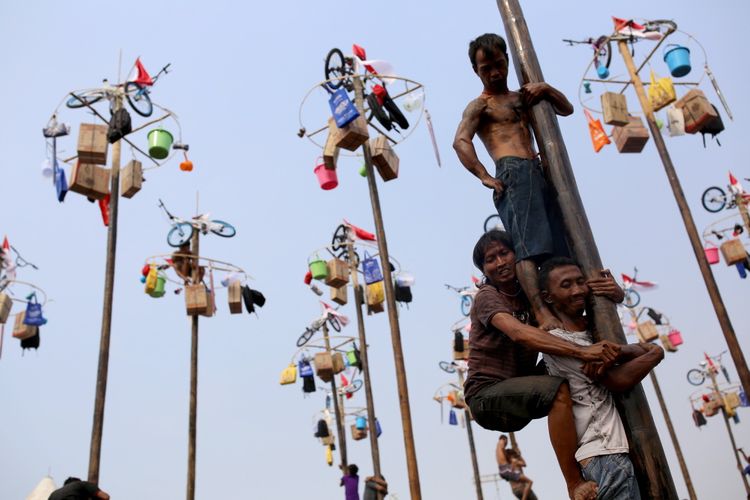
539;257;664;500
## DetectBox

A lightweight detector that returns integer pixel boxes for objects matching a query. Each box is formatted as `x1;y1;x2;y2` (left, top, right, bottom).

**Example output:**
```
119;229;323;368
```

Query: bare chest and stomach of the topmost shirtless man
476;91;536;161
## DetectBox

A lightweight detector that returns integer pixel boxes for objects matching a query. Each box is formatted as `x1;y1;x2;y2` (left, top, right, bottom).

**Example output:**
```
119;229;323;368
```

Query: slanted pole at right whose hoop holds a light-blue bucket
617;40;750;400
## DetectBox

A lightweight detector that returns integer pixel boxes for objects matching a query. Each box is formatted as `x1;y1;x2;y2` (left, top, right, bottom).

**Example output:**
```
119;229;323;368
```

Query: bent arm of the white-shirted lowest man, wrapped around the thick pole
598;342;664;392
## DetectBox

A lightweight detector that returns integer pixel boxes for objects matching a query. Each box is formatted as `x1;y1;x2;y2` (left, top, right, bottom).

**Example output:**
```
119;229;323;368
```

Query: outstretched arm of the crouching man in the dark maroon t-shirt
491;313;623;365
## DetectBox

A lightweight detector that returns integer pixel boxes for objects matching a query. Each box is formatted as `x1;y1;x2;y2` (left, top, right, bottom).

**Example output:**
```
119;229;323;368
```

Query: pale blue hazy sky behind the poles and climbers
0;0;750;500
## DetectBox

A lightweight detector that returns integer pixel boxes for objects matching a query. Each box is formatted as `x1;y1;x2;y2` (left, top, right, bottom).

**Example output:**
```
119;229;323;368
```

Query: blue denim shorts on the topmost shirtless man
493;156;570;261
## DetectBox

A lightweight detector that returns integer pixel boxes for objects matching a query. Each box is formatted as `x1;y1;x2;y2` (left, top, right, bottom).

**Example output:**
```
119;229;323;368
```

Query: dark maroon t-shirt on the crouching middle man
464;284;539;400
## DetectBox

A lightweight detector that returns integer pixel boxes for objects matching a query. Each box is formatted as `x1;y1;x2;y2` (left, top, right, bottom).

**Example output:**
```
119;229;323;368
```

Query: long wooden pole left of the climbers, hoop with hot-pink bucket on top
353;75;422;500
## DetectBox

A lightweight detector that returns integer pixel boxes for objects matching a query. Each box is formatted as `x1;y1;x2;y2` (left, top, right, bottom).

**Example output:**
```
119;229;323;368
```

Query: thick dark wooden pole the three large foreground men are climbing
497;0;677;500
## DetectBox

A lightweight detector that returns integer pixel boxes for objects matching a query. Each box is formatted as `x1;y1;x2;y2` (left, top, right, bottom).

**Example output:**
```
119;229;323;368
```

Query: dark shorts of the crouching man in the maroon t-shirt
468;375;565;432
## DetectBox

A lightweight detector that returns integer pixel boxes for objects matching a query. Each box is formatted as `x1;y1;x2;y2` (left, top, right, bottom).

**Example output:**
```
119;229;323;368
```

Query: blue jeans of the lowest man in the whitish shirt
581;453;641;500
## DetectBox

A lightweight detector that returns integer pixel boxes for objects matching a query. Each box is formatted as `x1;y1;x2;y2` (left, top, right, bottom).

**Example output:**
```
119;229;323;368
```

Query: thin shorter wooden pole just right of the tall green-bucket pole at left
187;229;201;500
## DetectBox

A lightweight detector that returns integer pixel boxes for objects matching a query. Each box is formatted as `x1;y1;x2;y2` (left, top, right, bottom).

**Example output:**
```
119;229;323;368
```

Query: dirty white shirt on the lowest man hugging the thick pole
543;329;628;462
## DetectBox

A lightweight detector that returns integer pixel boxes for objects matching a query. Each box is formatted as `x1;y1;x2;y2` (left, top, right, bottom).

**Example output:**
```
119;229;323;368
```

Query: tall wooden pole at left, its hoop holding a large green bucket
88;96;122;483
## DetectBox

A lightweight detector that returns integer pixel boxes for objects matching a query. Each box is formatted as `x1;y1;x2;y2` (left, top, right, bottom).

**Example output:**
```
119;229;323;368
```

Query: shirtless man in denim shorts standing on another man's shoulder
453;33;573;330
